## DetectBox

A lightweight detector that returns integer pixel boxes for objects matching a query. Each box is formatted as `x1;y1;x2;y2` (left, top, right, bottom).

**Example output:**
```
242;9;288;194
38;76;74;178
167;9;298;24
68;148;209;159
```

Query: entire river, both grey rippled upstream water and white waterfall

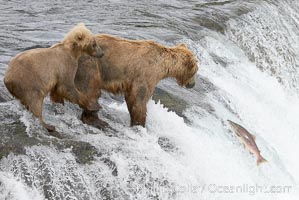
0;0;299;200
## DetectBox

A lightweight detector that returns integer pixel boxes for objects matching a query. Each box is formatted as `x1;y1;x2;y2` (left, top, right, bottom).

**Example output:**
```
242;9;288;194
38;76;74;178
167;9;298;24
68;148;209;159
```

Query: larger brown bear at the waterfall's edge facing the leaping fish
52;35;198;128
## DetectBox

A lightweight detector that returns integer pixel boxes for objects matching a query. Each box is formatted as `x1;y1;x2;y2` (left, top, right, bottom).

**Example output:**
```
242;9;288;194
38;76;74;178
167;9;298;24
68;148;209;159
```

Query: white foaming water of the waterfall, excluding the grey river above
0;0;299;200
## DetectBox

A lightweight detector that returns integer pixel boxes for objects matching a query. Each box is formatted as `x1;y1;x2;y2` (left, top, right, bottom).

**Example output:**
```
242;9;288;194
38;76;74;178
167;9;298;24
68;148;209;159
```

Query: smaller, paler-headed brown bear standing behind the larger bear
4;23;103;131
